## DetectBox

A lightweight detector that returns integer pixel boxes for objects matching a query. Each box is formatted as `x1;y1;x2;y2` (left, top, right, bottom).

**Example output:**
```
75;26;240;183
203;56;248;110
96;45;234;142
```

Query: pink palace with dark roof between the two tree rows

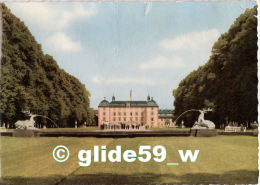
97;95;175;127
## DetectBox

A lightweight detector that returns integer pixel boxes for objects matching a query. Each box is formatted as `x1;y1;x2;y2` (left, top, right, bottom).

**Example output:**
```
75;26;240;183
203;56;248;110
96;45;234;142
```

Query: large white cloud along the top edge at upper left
8;2;97;31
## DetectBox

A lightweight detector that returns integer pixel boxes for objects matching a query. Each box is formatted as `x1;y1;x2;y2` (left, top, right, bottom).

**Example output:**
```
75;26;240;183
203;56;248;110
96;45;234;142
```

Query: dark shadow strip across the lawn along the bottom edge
0;169;258;185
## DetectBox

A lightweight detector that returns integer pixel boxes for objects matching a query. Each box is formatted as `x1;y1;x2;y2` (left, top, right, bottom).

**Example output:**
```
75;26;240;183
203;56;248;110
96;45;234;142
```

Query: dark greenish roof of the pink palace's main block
98;99;159;107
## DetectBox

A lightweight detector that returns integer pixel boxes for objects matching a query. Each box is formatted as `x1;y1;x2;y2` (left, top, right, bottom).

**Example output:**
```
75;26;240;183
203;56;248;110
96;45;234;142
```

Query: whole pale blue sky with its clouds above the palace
7;1;256;108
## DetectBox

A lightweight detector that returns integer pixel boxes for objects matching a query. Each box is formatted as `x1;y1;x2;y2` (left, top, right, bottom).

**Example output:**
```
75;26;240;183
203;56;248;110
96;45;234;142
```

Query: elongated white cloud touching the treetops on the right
159;29;220;51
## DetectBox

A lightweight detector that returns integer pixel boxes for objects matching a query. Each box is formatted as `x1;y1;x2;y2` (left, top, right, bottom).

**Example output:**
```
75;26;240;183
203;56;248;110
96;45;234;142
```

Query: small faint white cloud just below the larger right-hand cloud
138;56;185;70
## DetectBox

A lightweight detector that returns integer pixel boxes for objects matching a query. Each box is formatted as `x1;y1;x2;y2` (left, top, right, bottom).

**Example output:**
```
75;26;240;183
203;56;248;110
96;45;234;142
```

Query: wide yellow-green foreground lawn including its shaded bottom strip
0;136;258;185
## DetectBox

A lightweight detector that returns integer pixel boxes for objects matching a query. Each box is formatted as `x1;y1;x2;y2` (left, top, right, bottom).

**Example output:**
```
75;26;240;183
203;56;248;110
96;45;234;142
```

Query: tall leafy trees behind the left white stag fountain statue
0;3;95;127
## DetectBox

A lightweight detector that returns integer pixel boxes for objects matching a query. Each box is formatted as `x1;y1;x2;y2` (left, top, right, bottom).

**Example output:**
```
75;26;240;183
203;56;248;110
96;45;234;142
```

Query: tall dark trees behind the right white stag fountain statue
173;6;258;127
